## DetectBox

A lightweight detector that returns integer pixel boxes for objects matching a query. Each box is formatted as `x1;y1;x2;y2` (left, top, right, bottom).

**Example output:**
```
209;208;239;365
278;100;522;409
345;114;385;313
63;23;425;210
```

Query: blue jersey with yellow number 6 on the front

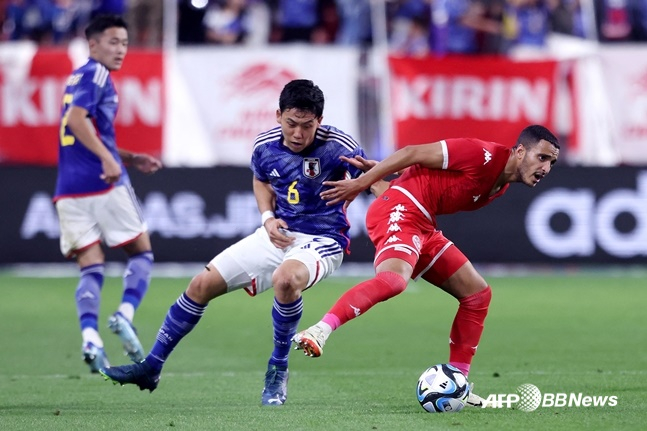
251;126;366;252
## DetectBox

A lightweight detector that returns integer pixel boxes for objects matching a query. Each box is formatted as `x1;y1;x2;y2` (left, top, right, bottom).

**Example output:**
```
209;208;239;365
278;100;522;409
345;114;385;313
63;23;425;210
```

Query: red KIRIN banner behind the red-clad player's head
389;57;558;148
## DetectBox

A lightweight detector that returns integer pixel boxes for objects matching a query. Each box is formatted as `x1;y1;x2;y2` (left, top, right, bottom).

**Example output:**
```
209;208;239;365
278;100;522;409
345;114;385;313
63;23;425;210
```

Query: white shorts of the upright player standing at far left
56;185;147;257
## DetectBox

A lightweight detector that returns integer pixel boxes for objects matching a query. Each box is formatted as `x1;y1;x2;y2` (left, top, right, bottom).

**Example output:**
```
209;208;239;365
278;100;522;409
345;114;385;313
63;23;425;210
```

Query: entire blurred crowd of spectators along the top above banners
0;0;647;51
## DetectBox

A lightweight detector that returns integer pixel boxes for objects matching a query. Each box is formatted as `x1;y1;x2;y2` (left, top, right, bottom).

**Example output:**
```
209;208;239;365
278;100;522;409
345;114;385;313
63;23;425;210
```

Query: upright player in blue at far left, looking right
54;15;161;372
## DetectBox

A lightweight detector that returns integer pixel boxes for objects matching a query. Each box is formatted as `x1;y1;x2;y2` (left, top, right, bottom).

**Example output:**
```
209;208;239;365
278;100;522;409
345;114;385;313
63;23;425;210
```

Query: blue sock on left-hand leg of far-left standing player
74;264;104;331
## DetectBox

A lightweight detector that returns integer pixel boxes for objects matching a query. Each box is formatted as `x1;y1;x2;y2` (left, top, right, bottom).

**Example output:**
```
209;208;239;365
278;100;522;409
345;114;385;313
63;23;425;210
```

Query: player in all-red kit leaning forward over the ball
293;125;559;404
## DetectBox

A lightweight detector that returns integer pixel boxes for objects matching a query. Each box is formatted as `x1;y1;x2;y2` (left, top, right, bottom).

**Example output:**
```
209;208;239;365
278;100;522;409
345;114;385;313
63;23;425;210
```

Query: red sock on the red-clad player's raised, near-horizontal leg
328;271;407;329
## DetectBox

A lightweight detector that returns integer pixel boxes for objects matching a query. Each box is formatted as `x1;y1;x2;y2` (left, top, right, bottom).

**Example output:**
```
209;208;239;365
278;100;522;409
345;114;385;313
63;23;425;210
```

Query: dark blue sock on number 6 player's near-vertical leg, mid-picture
269;298;303;368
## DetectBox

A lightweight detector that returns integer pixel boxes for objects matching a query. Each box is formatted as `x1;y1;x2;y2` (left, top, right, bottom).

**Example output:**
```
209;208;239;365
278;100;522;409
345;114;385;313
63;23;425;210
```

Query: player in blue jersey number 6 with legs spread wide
101;80;378;406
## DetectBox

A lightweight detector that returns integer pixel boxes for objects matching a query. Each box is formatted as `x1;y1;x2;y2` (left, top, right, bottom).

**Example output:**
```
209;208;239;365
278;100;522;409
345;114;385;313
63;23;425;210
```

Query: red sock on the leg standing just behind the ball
449;286;492;374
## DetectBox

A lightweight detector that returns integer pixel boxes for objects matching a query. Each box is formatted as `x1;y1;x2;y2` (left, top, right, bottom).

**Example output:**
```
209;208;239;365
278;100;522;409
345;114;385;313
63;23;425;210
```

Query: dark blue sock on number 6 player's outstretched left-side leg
146;293;207;371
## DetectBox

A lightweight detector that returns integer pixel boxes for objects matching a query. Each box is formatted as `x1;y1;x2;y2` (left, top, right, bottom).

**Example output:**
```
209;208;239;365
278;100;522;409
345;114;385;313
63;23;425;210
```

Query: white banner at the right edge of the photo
599;45;647;165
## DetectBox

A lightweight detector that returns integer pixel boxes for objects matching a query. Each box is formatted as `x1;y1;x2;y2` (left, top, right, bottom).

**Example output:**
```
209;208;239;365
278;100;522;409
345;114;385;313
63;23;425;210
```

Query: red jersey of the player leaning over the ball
391;139;510;223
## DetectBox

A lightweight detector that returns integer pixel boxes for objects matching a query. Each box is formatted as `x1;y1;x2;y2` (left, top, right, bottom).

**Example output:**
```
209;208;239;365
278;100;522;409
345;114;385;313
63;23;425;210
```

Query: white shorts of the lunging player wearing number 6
210;226;344;296
